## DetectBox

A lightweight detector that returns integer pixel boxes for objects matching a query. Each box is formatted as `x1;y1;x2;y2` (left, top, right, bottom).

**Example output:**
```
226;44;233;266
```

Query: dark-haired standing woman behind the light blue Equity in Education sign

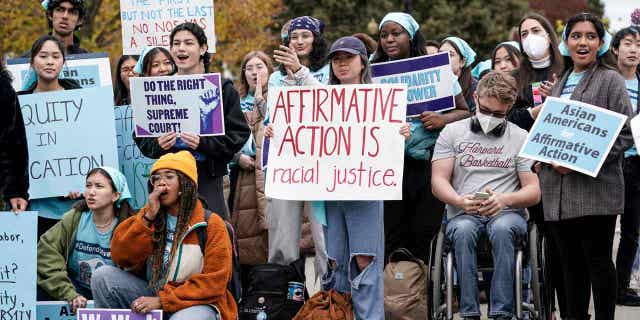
18;35;82;236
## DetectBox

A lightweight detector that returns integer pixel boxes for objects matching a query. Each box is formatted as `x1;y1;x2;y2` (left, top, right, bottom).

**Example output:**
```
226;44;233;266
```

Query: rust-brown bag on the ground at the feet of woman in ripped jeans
293;290;353;320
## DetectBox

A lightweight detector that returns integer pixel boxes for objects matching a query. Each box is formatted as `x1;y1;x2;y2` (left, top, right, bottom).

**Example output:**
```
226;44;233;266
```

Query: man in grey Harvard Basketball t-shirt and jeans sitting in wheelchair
431;71;540;319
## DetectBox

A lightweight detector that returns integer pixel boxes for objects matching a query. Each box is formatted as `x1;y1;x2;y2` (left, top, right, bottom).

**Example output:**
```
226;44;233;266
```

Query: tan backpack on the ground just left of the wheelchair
384;248;427;320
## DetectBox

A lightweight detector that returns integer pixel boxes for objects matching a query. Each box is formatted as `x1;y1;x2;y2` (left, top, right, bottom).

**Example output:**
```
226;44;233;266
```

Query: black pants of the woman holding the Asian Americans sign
549;215;617;320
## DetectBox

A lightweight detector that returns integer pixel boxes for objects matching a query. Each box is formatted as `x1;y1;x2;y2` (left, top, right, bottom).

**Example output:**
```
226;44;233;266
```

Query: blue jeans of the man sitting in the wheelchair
446;212;527;317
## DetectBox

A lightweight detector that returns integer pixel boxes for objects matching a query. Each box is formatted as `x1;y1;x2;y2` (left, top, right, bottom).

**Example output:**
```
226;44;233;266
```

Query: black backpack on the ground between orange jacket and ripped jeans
238;258;307;320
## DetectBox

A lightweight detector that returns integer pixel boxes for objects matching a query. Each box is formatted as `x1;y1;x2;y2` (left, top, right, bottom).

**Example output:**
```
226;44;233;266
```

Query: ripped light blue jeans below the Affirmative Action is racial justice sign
322;201;384;320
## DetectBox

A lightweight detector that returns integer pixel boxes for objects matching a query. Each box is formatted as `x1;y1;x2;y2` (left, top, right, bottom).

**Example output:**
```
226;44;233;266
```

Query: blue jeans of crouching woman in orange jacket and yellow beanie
91;266;220;320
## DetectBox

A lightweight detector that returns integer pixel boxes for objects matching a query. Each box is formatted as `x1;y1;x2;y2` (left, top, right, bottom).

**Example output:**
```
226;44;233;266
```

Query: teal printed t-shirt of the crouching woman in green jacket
67;211;118;290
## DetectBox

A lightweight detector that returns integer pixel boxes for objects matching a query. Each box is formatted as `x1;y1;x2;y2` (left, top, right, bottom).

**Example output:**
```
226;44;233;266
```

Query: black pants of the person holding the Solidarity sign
384;157;444;263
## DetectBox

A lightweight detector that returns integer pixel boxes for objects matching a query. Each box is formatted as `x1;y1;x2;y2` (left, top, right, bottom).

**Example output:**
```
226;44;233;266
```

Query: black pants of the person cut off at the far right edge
616;156;640;290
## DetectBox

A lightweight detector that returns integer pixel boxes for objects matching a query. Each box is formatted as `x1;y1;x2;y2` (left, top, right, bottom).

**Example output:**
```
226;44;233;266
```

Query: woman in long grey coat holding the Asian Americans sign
531;13;633;319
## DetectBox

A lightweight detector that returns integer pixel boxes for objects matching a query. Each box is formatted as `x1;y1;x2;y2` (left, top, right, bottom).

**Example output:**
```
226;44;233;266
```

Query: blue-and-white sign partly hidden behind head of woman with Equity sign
7;53;112;91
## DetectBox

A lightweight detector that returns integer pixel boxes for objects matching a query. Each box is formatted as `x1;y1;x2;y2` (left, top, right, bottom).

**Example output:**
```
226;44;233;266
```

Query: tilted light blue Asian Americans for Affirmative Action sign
520;97;627;177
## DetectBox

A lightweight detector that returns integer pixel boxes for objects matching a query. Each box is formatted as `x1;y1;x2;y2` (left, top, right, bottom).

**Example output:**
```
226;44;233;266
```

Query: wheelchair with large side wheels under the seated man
427;216;554;320
